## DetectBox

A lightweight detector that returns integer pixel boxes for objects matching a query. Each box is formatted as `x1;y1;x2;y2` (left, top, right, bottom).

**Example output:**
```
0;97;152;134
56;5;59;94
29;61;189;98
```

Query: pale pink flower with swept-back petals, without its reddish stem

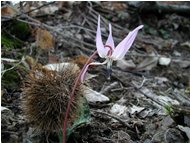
81;15;143;81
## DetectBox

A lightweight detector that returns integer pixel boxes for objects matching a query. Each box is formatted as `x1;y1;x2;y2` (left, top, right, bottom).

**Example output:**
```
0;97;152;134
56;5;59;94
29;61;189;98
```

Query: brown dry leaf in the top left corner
1;5;17;16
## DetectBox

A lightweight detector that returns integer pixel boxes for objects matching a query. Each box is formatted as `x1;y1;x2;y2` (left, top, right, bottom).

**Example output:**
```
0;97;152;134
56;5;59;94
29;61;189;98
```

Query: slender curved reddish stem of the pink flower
62;50;97;143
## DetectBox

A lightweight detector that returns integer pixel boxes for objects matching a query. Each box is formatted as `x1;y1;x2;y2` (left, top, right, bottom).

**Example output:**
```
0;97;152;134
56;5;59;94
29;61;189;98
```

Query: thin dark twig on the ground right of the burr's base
91;109;131;128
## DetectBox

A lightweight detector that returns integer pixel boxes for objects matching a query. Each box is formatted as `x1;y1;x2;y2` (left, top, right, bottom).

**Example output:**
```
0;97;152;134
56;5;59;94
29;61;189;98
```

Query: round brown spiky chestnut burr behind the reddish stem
22;66;84;133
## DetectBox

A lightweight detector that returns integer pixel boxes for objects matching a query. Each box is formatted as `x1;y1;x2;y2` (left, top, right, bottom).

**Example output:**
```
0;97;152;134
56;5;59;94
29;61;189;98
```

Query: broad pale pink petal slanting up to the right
112;25;143;60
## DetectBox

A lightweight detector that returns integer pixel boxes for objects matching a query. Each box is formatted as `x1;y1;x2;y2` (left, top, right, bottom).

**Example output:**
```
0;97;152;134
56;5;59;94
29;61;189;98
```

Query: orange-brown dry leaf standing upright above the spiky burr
36;28;54;49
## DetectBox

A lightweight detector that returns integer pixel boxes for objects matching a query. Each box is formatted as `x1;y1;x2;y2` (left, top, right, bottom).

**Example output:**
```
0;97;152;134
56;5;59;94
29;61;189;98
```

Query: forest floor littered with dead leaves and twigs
1;2;190;143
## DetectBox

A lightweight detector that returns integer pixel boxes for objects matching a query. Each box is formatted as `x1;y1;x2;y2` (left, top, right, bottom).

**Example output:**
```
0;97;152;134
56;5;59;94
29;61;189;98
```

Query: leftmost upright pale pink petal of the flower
96;15;108;58
